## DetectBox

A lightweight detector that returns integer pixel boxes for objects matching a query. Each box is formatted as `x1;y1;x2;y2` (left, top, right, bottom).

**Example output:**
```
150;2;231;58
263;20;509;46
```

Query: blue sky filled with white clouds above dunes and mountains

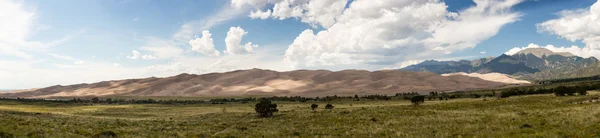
0;0;600;89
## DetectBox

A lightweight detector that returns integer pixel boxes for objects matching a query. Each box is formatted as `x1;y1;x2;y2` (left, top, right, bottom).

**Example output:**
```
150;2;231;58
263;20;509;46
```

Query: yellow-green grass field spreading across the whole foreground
0;92;600;138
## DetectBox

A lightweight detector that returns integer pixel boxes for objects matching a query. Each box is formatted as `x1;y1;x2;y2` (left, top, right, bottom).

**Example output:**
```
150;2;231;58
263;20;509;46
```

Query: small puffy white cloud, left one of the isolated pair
189;30;221;56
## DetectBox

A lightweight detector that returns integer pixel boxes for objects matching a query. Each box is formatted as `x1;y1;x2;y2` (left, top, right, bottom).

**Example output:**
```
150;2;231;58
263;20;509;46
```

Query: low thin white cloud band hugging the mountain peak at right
504;43;600;58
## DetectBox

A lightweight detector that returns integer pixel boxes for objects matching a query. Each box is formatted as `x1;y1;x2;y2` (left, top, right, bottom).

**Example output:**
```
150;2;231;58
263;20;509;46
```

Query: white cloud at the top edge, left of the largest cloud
231;0;348;28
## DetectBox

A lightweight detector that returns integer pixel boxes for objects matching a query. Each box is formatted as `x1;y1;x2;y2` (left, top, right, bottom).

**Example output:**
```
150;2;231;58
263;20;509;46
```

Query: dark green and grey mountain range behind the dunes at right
401;48;600;80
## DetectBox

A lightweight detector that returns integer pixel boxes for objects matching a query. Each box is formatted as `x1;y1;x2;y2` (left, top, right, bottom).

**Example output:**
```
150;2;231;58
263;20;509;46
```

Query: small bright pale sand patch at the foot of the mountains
442;72;531;84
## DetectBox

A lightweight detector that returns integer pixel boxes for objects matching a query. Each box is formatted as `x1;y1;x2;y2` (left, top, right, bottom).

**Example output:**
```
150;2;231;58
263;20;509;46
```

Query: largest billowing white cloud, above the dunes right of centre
284;0;522;68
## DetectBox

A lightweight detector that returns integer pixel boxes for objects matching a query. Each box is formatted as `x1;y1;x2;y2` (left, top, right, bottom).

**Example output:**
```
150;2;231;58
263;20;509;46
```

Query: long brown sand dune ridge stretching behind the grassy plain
0;69;506;98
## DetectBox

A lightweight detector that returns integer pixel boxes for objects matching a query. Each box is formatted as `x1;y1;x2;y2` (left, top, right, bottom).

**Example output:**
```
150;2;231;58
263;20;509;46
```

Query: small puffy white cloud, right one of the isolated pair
223;26;258;55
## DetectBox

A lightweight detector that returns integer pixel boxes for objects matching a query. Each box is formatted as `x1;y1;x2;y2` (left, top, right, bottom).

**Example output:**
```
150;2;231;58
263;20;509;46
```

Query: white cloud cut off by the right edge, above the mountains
537;1;600;49
